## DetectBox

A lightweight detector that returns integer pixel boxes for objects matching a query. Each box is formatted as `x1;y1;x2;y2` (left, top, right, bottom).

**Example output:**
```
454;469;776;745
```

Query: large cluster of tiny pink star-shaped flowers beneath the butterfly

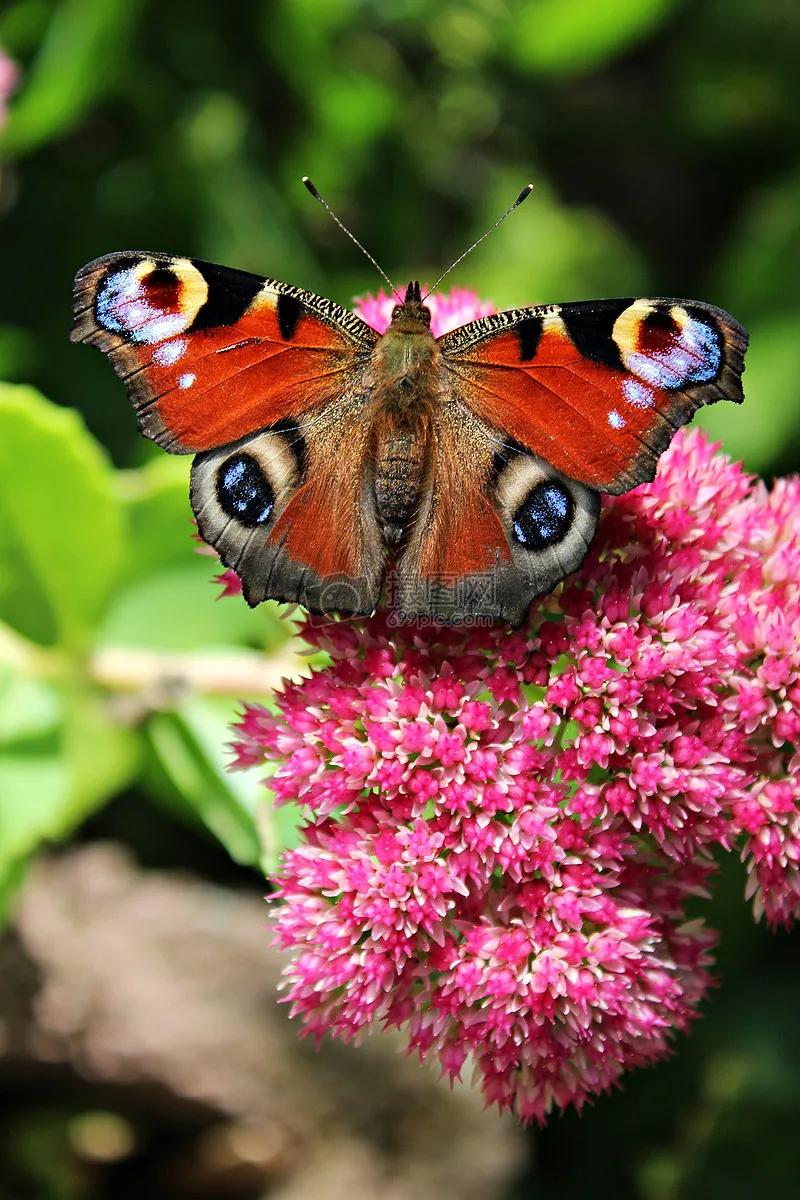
224;285;800;1121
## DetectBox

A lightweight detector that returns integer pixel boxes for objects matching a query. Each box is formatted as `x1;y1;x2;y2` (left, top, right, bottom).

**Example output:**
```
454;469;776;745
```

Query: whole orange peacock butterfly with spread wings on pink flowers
72;193;747;625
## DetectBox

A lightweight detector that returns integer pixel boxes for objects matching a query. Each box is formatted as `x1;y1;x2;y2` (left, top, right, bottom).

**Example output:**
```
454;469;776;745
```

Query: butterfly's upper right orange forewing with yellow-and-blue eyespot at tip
440;299;747;493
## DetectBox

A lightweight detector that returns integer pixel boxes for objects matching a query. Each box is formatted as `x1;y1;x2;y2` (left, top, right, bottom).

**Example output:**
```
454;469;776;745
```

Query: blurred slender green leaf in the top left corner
0;0;142;157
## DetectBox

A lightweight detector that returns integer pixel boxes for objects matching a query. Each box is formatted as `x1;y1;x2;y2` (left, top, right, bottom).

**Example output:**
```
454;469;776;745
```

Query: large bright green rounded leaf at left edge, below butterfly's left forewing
0;384;124;647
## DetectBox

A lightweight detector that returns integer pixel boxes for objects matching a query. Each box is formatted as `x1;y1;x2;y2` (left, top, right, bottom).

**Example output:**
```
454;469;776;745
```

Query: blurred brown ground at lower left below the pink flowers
0;844;525;1200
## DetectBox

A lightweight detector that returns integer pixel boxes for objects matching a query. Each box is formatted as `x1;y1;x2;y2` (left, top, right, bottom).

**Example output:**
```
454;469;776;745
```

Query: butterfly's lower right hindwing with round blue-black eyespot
392;405;600;625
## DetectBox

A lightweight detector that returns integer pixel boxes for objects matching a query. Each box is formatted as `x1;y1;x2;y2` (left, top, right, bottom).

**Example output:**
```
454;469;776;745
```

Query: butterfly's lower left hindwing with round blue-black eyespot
191;394;384;614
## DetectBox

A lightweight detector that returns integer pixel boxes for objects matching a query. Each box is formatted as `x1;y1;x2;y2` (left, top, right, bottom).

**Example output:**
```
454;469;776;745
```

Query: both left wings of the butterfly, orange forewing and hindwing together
72;252;383;612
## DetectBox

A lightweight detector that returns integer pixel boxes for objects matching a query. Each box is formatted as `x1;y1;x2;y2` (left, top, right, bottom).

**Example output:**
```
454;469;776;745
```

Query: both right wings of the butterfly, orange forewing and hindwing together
397;299;747;624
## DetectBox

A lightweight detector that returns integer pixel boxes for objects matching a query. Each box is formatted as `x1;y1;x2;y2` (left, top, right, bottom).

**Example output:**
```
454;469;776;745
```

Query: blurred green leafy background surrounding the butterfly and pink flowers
0;0;800;1200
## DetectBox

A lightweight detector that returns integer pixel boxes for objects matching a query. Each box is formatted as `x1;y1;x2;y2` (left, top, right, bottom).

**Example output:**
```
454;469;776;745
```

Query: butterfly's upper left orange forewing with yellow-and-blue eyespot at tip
72;252;378;454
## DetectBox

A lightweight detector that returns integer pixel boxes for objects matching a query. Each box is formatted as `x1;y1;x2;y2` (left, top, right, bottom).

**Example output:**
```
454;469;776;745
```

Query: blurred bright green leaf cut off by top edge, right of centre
507;0;678;74
